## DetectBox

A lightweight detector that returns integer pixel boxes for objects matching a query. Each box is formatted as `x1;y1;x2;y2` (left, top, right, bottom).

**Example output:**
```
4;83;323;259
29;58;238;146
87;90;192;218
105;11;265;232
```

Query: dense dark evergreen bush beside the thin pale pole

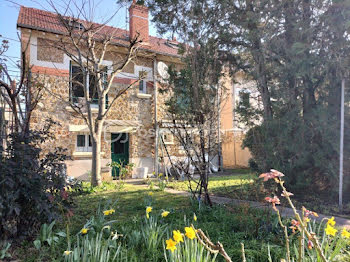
243;107;342;194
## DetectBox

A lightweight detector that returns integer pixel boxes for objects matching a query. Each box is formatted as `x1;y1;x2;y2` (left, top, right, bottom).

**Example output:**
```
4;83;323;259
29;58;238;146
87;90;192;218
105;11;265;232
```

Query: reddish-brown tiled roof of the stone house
17;6;178;56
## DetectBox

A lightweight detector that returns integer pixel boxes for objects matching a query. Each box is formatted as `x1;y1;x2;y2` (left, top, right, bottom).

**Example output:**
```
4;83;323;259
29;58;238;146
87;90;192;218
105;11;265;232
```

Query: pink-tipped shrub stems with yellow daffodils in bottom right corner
260;169;350;262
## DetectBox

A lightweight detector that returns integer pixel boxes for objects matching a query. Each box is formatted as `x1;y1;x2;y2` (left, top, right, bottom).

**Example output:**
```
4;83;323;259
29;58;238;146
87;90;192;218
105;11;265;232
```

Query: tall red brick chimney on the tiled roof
129;0;149;43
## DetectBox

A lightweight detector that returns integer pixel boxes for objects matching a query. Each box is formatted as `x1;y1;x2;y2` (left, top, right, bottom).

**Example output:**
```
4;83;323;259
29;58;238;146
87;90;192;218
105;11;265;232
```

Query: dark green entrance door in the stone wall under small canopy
111;133;129;177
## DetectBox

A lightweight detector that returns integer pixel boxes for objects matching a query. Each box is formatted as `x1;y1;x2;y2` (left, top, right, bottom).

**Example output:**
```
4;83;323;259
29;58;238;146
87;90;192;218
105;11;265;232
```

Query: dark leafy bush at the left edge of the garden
0;121;72;239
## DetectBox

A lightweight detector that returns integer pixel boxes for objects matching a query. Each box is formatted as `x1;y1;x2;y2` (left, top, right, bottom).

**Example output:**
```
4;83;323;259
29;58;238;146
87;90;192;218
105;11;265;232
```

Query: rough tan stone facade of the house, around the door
22;24;183;179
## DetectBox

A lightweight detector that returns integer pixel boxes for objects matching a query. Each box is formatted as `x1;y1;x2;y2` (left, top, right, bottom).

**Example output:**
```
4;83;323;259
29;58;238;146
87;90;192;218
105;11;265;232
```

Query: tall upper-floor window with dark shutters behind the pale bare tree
70;63;108;104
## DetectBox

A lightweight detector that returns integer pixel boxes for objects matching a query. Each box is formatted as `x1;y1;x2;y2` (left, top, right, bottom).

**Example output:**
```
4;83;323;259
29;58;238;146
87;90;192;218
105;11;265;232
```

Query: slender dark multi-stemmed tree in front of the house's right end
162;42;225;205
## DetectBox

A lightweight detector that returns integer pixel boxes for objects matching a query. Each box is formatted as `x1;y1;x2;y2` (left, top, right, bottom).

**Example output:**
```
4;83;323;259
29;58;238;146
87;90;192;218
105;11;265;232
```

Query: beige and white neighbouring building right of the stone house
221;69;260;168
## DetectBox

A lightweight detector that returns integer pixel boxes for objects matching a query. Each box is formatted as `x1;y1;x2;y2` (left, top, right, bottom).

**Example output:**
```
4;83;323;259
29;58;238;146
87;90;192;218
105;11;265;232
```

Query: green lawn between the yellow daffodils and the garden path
16;182;284;262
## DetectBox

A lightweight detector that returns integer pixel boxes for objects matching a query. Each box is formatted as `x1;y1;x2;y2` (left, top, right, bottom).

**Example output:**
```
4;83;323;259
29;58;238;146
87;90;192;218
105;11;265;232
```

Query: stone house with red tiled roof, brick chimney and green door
17;3;185;179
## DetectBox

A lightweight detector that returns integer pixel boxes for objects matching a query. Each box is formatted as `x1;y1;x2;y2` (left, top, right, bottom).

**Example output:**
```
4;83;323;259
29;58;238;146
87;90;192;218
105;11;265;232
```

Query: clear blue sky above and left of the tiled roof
0;0;157;76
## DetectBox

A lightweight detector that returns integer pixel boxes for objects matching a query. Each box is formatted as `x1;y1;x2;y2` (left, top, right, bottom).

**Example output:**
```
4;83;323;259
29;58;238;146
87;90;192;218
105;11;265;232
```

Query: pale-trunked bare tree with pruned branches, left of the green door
42;1;143;186
